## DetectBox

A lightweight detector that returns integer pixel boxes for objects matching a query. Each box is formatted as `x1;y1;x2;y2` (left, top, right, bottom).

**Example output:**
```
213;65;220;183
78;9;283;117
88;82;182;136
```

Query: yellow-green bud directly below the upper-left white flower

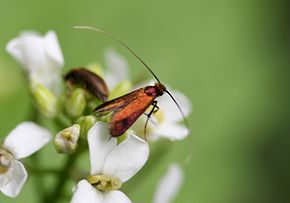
32;84;57;118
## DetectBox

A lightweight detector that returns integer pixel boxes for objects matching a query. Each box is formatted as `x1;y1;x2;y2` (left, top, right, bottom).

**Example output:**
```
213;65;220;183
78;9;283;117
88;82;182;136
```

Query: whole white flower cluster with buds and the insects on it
0;31;191;203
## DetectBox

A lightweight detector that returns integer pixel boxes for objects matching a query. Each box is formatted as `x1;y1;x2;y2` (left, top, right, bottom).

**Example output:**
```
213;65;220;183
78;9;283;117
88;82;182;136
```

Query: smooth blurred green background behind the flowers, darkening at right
0;0;290;203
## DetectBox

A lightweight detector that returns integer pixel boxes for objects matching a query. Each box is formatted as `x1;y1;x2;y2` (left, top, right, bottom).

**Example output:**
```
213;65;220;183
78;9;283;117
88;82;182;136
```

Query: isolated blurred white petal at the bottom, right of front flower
153;164;184;203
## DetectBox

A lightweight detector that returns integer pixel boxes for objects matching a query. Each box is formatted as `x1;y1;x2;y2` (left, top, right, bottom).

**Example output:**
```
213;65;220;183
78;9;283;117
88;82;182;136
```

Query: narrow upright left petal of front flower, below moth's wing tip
88;122;117;174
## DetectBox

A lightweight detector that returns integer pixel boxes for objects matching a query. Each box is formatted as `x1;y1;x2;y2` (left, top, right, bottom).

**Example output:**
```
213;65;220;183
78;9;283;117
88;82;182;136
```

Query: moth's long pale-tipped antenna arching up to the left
74;26;160;83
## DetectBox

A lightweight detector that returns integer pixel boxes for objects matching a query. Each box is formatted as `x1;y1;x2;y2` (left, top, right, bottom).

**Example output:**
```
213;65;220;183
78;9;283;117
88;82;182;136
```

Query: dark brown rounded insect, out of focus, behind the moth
64;68;109;102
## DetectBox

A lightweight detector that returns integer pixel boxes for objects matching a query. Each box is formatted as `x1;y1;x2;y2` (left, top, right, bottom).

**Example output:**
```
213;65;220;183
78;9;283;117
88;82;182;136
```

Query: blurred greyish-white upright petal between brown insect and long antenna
105;48;128;89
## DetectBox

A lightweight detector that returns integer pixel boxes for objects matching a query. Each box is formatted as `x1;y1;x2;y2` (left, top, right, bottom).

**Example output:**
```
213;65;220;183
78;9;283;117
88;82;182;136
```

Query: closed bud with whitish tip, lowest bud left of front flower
54;124;81;153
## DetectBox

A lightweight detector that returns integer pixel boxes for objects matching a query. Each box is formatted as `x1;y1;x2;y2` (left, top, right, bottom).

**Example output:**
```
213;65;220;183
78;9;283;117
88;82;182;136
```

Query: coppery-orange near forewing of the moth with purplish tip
109;90;156;137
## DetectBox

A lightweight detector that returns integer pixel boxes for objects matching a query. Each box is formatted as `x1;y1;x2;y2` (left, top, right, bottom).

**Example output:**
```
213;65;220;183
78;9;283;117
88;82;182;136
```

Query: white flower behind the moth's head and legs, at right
133;82;192;141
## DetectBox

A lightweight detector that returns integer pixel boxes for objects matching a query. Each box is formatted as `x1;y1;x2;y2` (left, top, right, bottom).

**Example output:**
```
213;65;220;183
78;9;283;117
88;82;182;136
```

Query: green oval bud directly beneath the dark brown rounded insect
65;88;86;117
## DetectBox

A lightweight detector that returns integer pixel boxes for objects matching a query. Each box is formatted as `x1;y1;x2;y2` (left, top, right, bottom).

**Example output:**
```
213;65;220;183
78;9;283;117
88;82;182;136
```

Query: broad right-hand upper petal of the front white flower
103;134;149;182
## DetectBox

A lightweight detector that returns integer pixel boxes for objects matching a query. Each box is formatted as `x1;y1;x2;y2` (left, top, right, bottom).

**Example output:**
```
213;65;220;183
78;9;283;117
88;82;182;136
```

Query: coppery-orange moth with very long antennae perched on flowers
75;26;189;137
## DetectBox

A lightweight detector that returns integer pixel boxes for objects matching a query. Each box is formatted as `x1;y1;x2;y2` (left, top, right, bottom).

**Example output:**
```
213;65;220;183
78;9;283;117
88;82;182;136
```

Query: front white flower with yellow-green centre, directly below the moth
71;122;149;203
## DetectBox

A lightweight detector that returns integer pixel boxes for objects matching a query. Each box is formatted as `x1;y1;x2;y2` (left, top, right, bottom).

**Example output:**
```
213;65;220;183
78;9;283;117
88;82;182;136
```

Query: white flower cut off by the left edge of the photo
0;122;51;197
